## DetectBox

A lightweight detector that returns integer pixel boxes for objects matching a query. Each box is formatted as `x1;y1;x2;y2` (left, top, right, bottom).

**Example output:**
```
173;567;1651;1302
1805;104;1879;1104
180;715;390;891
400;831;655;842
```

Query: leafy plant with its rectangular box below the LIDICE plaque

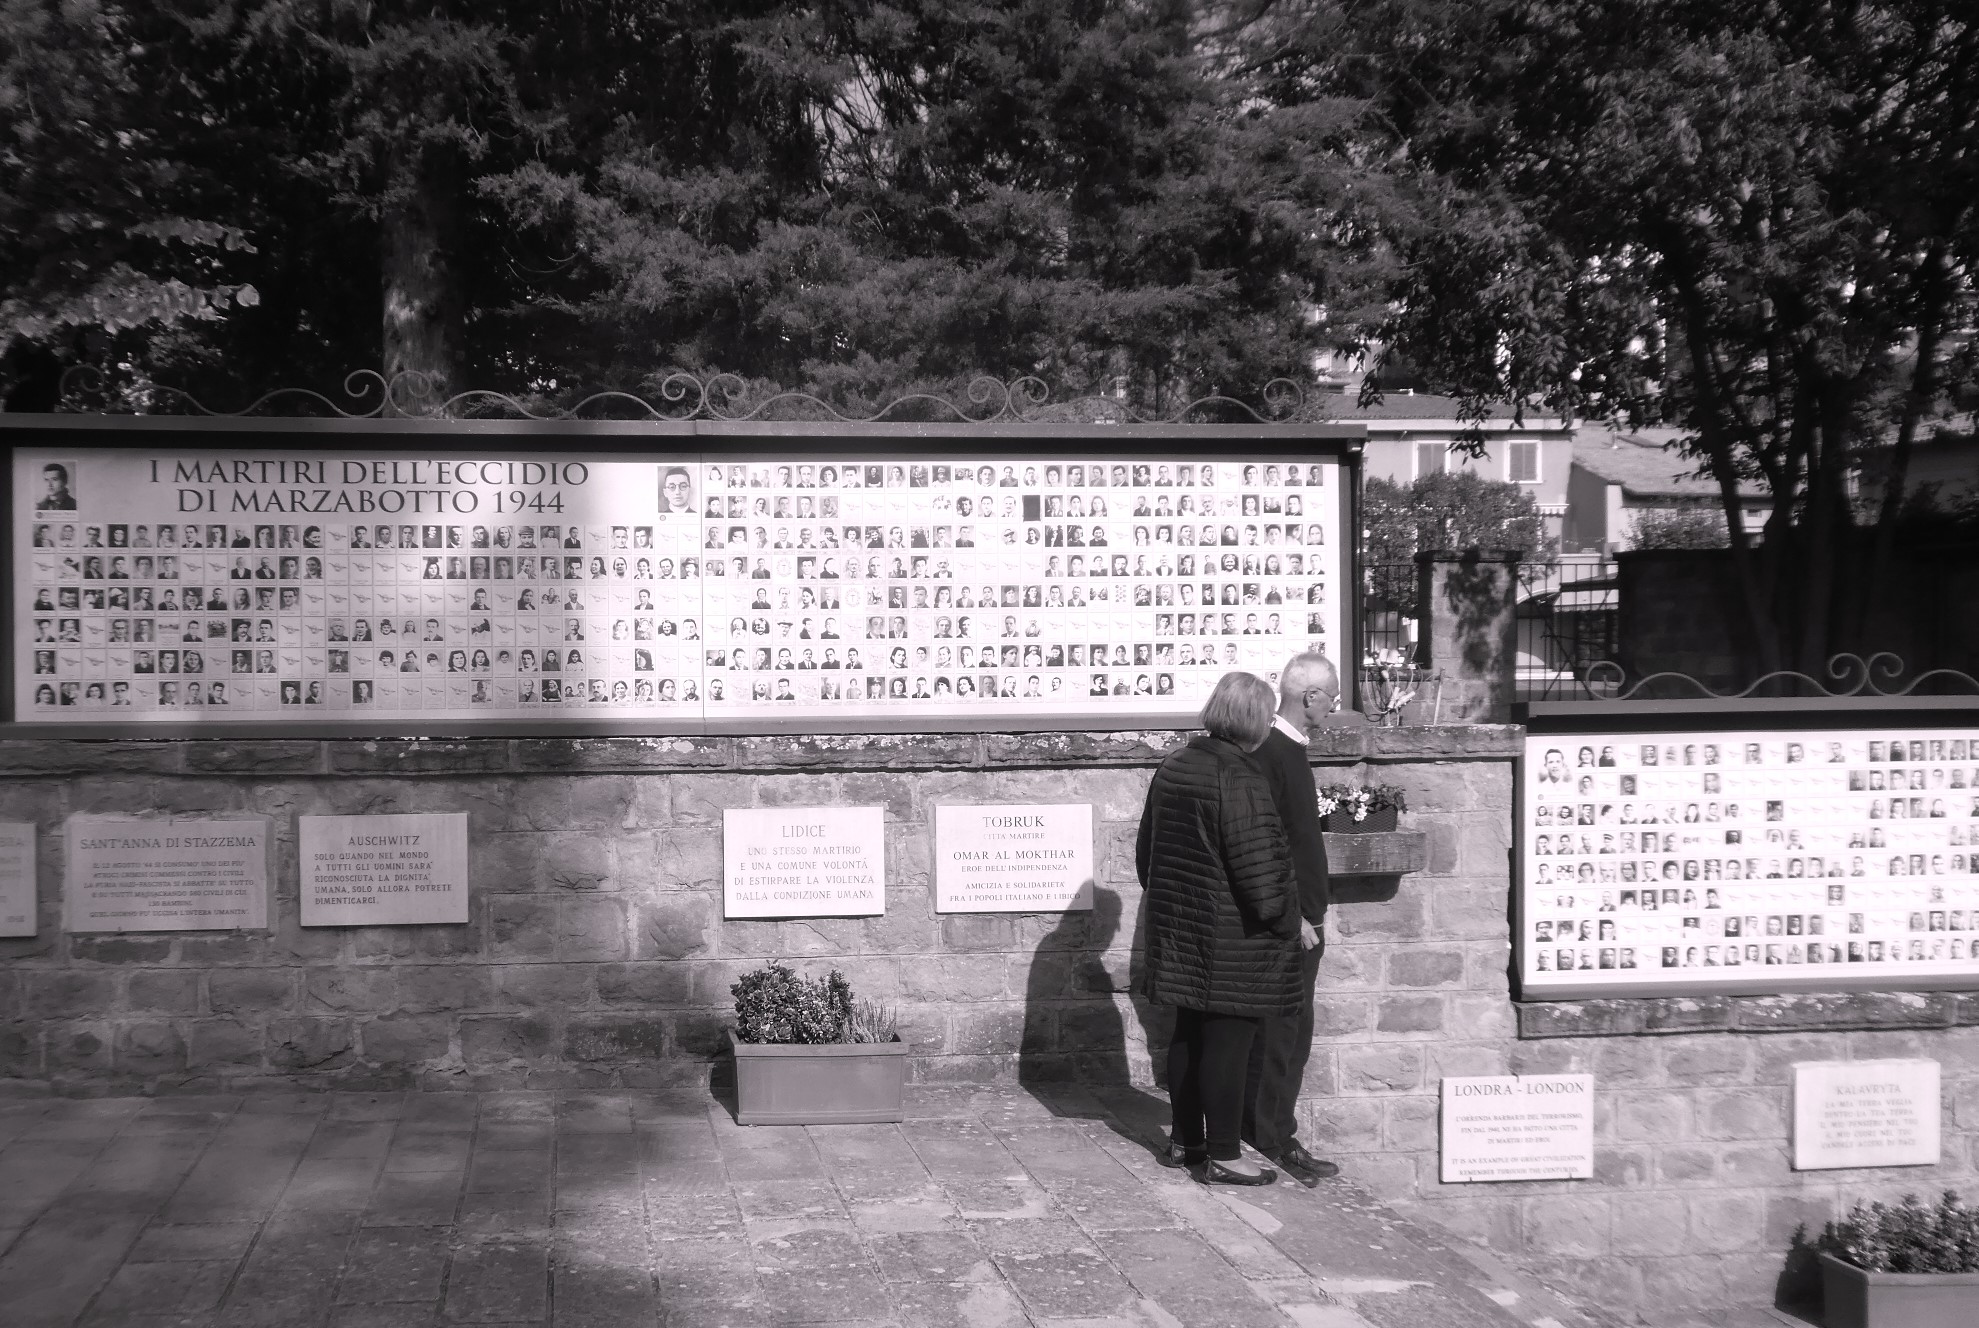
728;962;908;1124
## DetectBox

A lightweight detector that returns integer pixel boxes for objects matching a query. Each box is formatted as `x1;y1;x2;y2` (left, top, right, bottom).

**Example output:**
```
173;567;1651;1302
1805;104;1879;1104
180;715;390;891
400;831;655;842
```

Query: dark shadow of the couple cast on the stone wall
1017;885;1174;1150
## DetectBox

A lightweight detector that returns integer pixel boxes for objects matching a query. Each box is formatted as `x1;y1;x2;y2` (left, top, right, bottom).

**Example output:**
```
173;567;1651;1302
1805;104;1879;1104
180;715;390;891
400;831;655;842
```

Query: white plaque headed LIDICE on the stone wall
722;807;887;918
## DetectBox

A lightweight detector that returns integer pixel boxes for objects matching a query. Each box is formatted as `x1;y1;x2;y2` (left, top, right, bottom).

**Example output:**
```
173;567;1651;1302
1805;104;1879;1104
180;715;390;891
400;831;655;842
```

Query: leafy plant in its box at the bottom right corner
1819;1189;1979;1328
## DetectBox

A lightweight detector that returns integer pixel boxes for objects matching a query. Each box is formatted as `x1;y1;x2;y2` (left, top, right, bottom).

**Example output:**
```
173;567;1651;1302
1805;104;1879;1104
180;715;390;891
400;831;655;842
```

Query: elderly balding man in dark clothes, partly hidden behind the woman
1243;651;1340;1186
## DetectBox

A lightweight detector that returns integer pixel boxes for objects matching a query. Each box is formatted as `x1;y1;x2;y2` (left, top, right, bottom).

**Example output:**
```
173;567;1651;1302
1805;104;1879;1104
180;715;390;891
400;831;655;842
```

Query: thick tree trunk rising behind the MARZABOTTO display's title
384;148;461;416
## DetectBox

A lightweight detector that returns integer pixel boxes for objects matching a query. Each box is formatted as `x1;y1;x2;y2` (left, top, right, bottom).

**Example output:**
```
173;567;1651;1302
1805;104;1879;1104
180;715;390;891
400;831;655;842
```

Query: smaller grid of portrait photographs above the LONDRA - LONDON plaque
1520;726;1979;992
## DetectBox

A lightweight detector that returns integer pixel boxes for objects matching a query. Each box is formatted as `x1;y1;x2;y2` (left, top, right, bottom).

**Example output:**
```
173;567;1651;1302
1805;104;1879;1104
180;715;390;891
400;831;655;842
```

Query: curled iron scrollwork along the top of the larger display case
61;364;1306;424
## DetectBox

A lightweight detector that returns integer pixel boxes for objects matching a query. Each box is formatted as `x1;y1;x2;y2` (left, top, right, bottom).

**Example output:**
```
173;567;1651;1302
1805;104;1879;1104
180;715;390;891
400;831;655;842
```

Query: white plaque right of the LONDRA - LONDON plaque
1793;1061;1939;1172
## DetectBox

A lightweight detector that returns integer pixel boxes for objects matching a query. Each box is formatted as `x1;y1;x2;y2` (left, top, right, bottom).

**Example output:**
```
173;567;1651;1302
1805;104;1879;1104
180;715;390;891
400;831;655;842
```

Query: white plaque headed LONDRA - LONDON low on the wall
1443;1075;1595;1184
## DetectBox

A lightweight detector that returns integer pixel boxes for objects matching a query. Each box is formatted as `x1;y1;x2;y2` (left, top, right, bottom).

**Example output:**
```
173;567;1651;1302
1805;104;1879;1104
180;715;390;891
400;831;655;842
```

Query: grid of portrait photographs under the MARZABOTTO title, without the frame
16;453;1340;720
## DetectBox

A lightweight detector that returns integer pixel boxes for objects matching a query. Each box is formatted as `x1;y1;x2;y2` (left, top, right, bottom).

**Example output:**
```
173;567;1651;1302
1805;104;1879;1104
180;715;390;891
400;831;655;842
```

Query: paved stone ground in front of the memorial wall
0;1087;1781;1328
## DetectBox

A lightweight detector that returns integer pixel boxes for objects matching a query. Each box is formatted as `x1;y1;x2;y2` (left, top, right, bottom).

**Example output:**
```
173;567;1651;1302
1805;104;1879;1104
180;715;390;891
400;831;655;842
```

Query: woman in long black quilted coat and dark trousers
1134;673;1300;1186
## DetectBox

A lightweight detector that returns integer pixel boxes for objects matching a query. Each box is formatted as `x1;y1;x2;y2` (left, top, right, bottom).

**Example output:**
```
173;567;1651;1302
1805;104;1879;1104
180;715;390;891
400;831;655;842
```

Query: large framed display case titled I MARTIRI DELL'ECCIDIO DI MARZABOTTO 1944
6;418;1360;732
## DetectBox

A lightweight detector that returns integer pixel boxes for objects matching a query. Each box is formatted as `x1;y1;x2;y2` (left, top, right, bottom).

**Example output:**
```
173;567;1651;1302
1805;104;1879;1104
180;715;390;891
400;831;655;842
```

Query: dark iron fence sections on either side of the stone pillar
1360;558;1619;701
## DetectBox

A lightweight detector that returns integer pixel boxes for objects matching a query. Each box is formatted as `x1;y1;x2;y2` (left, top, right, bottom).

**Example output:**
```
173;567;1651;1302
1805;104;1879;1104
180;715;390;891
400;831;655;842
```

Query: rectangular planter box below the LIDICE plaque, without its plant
728;1029;908;1124
